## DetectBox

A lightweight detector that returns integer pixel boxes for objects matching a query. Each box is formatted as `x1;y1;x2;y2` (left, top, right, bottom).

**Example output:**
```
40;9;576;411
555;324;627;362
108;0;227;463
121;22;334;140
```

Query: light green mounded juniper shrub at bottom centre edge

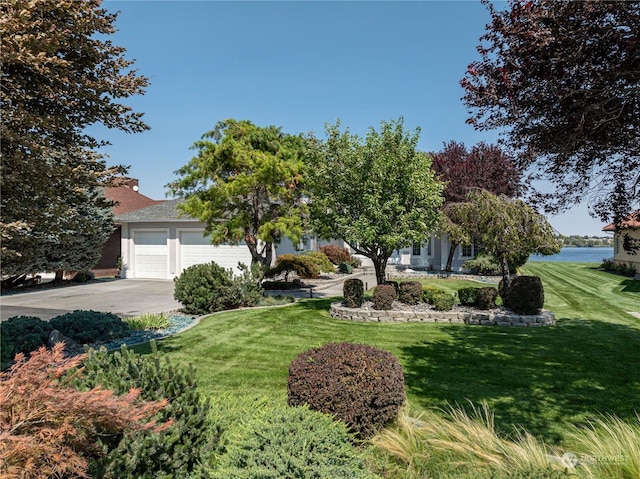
211;406;375;479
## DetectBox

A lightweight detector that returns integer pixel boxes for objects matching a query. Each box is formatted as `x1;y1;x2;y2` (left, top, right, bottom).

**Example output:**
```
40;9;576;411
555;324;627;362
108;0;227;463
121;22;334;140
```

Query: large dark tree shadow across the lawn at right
401;319;640;443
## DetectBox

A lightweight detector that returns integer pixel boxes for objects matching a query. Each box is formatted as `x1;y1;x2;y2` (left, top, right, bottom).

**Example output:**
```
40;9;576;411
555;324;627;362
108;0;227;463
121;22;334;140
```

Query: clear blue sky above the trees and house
99;0;603;235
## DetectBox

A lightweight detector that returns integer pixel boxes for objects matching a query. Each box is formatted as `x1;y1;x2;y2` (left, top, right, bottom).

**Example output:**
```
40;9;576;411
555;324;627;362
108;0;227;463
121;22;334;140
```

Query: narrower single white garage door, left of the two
133;231;169;279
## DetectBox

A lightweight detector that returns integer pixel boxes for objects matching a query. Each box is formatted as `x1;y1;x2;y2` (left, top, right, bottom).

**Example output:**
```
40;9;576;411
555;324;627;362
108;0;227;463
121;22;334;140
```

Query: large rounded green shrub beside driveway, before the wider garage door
173;262;263;315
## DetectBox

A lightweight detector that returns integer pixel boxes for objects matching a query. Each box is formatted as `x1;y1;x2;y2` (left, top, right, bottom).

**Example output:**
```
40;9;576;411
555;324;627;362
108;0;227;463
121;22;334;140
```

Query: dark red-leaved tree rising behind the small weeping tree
432;141;523;271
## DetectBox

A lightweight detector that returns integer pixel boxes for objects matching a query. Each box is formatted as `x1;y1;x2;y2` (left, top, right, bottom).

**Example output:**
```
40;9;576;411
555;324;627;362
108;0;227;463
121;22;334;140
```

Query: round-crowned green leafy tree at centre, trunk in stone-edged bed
308;118;444;284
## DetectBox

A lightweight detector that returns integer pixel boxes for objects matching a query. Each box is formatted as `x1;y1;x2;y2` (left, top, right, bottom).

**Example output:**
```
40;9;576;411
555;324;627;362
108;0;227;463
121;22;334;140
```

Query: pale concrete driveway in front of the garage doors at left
0;279;181;321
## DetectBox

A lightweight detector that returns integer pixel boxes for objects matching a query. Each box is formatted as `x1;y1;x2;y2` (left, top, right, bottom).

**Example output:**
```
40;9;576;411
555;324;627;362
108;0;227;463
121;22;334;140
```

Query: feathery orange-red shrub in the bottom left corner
0;344;166;479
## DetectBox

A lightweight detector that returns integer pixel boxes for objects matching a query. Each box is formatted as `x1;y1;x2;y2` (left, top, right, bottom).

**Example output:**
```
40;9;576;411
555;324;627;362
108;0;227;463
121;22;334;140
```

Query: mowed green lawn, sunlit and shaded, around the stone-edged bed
132;263;640;444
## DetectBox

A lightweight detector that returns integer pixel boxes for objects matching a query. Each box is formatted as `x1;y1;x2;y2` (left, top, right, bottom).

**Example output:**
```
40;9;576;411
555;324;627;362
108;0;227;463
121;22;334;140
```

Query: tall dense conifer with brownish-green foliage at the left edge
0;0;148;280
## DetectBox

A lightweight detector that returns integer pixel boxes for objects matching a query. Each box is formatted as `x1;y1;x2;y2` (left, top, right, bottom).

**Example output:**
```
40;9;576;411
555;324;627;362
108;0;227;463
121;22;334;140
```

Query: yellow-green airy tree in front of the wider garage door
167;119;307;270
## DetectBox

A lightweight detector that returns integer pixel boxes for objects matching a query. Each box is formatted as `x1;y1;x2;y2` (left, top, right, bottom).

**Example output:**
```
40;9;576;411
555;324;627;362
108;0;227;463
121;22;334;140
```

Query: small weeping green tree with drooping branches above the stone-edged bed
450;190;562;288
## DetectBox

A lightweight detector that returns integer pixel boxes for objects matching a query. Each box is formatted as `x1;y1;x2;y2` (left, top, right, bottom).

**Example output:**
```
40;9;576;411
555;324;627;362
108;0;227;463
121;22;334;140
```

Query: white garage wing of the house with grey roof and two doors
115;199;251;279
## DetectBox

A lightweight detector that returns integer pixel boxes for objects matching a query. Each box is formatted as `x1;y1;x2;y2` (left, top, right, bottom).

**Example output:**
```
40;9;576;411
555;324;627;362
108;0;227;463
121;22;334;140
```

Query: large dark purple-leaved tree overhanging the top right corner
461;0;640;222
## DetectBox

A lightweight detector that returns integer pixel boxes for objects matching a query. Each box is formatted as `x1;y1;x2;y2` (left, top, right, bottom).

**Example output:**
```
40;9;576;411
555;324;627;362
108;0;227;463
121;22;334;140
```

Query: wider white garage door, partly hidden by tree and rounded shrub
180;231;251;272
